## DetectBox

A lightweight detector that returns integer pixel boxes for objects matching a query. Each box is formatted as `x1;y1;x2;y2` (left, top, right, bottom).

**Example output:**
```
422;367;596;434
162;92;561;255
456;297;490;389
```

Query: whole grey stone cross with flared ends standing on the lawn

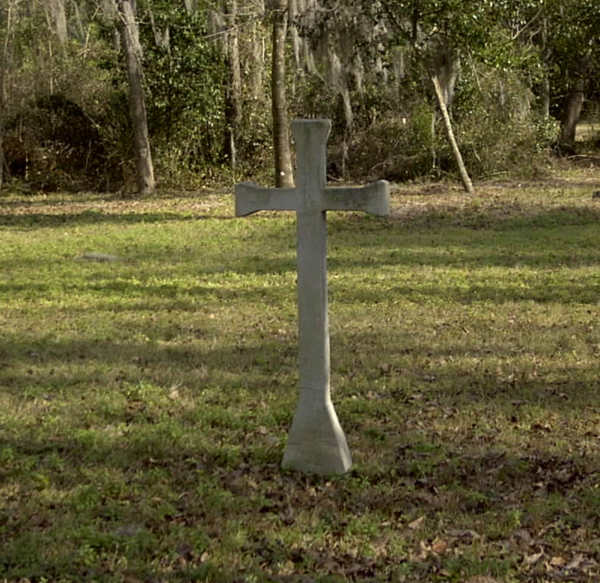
235;119;389;474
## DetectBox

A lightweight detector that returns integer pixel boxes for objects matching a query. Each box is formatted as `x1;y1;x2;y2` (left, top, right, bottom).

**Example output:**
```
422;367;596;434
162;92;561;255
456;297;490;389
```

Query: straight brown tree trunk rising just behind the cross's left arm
271;0;294;187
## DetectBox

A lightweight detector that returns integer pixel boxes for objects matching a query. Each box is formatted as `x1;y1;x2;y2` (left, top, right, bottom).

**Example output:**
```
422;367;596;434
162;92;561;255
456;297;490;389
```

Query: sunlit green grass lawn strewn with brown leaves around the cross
0;170;600;583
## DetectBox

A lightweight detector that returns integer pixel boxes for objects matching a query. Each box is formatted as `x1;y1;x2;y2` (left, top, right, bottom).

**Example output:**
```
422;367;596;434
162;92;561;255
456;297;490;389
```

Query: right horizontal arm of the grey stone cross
323;180;390;217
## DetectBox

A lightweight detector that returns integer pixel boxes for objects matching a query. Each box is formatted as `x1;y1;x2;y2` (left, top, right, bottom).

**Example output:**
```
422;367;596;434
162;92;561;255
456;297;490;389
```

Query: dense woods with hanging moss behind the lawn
0;0;600;193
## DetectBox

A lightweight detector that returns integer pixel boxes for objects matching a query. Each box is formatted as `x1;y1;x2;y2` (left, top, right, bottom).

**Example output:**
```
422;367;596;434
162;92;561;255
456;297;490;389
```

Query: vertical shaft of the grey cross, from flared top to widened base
282;120;352;474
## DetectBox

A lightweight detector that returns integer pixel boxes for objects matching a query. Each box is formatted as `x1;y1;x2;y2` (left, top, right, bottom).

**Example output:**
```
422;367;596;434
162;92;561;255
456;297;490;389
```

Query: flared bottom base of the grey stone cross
281;389;352;475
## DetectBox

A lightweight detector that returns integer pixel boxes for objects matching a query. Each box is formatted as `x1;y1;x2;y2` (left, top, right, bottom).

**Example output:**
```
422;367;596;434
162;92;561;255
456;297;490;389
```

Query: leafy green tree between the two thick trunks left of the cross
140;0;229;181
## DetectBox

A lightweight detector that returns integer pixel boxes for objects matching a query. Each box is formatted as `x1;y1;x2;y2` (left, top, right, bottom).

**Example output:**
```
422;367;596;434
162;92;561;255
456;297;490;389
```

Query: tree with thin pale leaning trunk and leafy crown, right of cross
298;0;489;193
